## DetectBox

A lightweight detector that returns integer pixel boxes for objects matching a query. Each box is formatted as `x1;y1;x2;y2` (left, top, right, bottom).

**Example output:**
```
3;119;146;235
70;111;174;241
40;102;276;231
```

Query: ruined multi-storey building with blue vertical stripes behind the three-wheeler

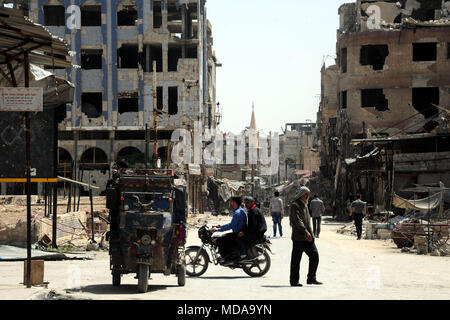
28;0;218;194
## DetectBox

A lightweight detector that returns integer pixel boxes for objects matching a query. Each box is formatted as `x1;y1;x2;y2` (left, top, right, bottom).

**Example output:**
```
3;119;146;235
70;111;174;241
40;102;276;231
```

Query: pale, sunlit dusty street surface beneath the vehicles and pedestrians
0;217;450;300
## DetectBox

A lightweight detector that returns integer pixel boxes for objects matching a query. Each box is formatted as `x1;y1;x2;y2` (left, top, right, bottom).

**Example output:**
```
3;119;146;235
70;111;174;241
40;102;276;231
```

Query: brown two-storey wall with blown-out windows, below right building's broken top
337;25;450;135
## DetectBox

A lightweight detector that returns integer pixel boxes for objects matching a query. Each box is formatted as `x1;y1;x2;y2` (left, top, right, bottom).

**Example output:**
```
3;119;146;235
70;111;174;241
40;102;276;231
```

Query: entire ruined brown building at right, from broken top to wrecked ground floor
318;0;450;219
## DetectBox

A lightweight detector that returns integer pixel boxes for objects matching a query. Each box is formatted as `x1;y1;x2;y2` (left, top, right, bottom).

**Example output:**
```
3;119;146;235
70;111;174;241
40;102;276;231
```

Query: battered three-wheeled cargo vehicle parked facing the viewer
107;169;187;293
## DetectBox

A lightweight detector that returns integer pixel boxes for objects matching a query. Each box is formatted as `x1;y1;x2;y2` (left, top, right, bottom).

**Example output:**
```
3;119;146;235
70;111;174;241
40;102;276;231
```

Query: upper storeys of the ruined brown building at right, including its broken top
337;0;450;137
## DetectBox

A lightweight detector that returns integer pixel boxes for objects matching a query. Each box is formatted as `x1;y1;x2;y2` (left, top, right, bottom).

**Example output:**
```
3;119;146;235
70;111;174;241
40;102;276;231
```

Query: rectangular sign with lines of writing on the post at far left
0;87;44;112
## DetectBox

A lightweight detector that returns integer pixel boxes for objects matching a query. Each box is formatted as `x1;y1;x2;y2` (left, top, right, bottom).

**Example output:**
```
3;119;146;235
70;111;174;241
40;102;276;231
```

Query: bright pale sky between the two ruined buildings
206;0;344;133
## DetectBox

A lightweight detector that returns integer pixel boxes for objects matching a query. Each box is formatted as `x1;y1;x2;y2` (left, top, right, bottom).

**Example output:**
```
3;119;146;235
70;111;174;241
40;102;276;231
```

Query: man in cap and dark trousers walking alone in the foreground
289;187;322;287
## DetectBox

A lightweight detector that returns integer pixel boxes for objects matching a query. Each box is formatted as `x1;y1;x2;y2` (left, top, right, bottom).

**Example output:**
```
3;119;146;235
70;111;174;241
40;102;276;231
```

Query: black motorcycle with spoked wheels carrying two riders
185;225;272;277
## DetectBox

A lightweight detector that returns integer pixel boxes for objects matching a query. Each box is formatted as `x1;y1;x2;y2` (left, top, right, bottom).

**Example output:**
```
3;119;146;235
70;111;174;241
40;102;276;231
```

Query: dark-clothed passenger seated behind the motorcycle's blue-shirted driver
237;197;267;261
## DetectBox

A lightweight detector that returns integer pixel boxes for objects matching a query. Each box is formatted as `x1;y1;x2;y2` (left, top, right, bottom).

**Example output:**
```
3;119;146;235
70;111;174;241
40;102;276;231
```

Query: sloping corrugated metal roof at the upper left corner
0;7;73;68
